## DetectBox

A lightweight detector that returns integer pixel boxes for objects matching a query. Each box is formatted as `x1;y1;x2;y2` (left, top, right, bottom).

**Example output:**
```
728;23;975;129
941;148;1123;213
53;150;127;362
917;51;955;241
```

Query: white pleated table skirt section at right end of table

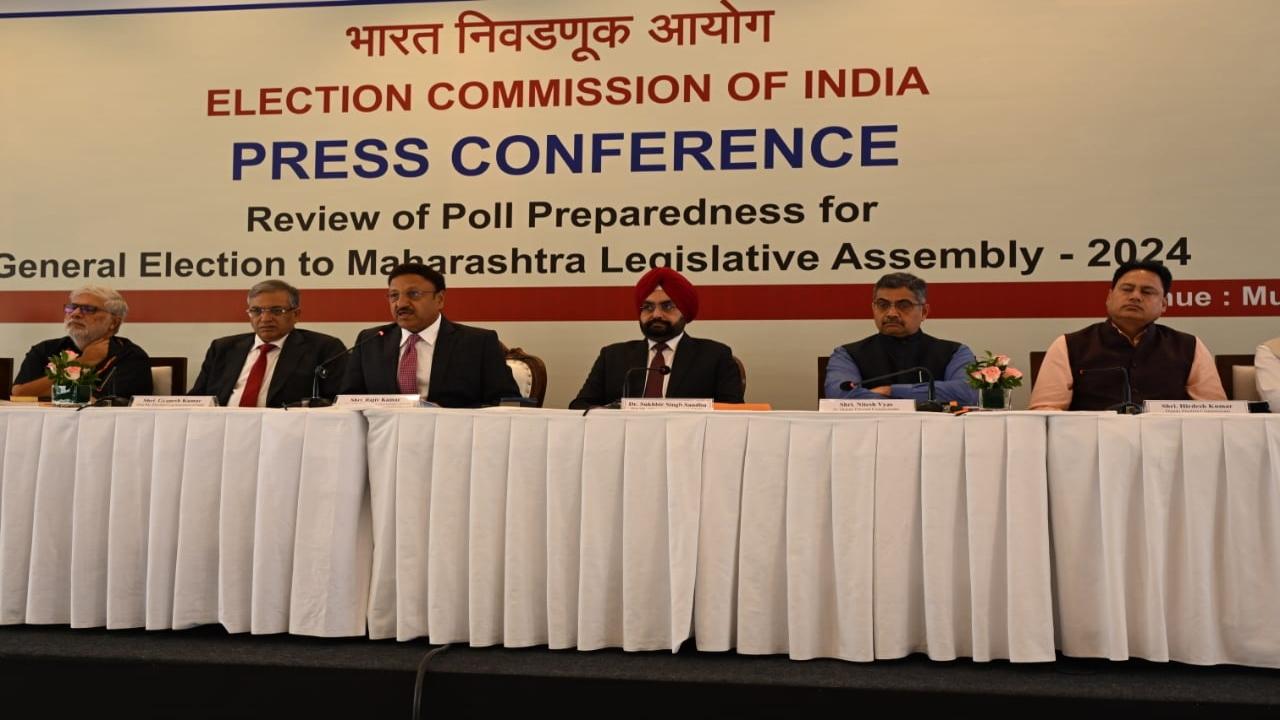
1048;414;1280;667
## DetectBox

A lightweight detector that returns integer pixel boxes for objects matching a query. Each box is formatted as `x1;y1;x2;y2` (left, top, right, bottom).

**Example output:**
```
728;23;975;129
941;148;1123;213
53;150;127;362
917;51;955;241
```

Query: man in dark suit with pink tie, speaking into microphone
342;263;520;407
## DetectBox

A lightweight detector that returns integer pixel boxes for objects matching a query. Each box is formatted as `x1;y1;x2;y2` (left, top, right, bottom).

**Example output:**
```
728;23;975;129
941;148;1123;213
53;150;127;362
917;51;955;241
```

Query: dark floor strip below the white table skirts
0;625;1280;720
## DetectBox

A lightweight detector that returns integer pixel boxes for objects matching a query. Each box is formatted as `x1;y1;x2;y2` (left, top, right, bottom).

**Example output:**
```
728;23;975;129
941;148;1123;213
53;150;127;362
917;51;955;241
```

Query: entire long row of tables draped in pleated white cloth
0;406;1280;667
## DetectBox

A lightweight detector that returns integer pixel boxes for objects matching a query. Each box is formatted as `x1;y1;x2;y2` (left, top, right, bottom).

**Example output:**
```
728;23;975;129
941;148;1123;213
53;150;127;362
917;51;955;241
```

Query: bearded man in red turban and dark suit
568;268;742;410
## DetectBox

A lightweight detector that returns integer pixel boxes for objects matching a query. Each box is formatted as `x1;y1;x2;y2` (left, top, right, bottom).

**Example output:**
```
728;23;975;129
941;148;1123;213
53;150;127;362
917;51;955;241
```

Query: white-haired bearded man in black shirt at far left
10;286;151;397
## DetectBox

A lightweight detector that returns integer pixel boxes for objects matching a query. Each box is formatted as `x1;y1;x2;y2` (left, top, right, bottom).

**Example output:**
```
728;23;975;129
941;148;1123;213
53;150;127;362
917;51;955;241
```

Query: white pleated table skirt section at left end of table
0;406;372;637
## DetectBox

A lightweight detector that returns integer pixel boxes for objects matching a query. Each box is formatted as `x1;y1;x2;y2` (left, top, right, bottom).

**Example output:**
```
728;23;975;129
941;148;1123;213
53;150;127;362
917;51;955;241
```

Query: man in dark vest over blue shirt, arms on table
823;273;978;405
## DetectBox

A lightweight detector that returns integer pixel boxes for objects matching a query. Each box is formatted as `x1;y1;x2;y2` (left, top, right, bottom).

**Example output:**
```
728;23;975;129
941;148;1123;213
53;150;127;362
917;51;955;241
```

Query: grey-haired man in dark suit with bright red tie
189;281;347;407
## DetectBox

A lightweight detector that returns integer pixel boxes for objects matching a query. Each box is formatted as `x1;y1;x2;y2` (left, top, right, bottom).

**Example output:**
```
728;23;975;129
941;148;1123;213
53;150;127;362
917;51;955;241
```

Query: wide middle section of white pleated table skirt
366;410;1055;661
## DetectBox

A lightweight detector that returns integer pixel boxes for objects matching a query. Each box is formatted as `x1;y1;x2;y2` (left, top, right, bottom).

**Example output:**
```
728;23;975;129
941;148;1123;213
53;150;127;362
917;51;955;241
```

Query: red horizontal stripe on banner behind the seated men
0;278;1280;323
